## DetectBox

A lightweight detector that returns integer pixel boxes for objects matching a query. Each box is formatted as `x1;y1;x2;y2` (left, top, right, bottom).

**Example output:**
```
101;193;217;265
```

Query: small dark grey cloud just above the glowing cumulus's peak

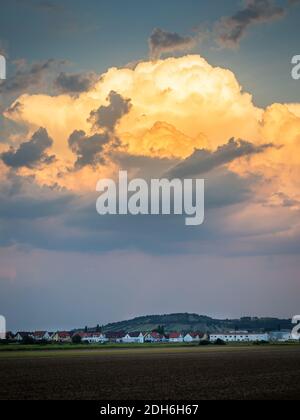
149;28;197;60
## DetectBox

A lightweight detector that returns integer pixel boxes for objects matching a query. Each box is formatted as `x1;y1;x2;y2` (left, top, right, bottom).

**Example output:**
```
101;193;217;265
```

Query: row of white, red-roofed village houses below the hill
7;331;292;344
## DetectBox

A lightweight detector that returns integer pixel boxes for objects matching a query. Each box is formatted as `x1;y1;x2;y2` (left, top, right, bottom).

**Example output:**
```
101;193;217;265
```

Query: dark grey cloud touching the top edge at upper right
216;0;286;47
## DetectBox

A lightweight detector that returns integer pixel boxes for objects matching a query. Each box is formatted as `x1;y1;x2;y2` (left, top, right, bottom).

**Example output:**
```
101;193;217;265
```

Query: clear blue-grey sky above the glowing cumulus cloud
0;0;300;106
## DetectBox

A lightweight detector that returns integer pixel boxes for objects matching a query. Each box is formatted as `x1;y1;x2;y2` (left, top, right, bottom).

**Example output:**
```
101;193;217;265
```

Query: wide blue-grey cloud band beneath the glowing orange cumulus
0;162;299;255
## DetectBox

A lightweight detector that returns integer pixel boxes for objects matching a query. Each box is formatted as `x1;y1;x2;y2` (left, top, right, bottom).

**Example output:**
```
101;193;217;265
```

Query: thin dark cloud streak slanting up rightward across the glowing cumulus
168;138;272;178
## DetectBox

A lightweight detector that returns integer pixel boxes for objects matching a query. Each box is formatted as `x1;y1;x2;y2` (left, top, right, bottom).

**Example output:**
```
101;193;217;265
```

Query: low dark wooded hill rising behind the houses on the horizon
96;313;292;333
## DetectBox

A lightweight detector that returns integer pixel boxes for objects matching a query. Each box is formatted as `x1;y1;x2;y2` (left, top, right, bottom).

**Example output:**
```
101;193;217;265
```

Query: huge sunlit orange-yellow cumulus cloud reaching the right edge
2;55;300;207
